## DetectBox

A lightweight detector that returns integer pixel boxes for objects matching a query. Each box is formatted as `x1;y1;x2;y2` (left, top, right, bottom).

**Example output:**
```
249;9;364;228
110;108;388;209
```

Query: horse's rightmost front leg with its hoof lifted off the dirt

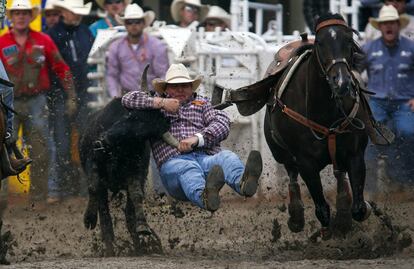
348;152;371;221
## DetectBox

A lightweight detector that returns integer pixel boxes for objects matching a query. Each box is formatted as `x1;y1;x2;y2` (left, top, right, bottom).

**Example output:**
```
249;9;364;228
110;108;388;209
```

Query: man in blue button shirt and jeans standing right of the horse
363;5;414;182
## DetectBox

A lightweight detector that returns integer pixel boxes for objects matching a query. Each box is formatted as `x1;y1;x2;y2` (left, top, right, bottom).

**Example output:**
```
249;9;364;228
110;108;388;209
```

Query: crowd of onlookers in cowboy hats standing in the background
0;0;414;203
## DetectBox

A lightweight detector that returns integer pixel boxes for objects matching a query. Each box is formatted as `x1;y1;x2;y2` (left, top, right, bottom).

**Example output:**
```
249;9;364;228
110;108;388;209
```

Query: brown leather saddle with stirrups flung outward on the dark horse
212;33;395;145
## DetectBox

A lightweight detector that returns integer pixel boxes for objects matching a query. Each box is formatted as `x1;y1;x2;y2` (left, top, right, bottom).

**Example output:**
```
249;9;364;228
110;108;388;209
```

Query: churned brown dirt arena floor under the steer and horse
2;179;414;269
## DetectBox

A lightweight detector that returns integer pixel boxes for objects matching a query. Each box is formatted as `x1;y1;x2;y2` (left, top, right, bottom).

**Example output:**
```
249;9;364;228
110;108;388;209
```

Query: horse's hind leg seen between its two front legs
333;170;352;234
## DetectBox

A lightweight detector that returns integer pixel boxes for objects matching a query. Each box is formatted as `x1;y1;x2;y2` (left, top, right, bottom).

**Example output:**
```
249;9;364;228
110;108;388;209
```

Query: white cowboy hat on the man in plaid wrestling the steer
152;64;203;94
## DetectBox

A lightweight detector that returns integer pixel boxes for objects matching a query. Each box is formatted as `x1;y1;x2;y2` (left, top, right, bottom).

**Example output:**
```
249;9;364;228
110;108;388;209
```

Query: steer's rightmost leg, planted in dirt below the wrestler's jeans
125;176;162;254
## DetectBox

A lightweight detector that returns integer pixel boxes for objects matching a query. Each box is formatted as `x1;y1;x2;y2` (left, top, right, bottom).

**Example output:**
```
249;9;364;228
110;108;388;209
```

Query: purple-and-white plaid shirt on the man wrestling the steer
122;91;230;167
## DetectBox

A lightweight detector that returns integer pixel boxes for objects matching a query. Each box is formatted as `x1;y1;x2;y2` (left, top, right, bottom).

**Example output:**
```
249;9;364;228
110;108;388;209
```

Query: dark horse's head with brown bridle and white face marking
314;14;356;99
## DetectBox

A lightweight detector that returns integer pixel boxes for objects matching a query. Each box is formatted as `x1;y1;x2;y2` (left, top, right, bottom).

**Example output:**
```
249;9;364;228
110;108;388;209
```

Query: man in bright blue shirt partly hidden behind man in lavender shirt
89;0;131;37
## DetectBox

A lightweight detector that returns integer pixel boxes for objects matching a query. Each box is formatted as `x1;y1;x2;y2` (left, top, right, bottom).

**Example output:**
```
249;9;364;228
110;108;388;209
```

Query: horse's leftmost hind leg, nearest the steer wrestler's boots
285;162;305;233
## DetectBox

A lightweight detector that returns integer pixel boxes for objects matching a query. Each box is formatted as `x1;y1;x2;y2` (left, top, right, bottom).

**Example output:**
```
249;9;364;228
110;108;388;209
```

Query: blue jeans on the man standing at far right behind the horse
366;98;414;182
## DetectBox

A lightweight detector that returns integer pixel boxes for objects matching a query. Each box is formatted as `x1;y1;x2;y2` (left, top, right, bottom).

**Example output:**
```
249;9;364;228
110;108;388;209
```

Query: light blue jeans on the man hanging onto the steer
160;150;244;208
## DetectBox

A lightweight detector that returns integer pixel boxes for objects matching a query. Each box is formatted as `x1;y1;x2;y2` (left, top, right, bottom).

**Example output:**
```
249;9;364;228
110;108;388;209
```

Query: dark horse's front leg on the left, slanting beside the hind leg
298;159;331;232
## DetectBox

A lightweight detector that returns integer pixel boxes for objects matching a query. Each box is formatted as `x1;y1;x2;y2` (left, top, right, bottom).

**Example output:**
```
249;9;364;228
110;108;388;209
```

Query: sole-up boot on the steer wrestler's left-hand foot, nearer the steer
202;165;224;212
